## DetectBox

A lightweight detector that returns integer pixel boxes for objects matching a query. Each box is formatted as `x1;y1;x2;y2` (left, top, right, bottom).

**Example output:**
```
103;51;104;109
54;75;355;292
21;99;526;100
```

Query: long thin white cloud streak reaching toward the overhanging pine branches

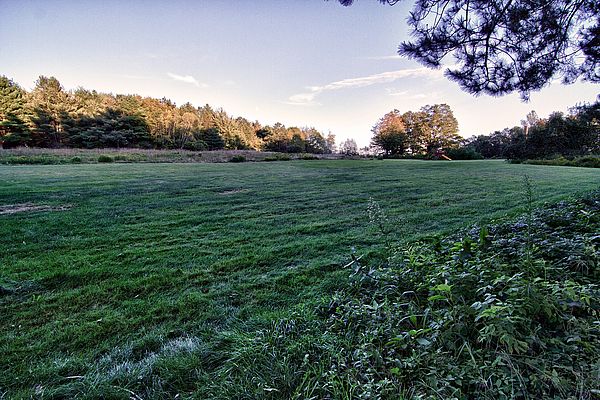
286;67;443;106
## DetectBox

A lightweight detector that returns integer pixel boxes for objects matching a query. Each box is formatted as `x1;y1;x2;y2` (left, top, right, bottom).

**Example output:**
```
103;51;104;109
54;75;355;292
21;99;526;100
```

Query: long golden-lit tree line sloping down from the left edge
0;76;335;154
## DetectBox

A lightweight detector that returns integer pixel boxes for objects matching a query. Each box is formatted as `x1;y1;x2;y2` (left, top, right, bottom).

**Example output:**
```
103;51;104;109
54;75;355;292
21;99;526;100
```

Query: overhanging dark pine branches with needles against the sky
338;0;600;99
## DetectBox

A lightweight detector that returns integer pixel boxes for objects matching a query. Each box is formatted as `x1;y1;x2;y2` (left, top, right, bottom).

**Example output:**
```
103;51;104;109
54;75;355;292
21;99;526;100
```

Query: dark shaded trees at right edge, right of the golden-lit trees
463;101;600;160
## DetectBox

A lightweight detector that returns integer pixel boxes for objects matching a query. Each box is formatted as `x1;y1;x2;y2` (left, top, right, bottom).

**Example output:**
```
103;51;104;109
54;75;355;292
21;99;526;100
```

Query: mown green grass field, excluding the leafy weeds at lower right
0;160;600;399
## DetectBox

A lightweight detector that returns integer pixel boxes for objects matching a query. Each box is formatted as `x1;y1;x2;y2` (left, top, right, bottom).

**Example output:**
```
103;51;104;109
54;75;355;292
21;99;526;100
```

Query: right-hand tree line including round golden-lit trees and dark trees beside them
369;101;600;160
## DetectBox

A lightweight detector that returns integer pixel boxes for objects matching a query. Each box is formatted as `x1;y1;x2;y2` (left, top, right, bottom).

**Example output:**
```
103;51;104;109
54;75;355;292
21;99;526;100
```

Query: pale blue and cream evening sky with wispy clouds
0;0;599;146
